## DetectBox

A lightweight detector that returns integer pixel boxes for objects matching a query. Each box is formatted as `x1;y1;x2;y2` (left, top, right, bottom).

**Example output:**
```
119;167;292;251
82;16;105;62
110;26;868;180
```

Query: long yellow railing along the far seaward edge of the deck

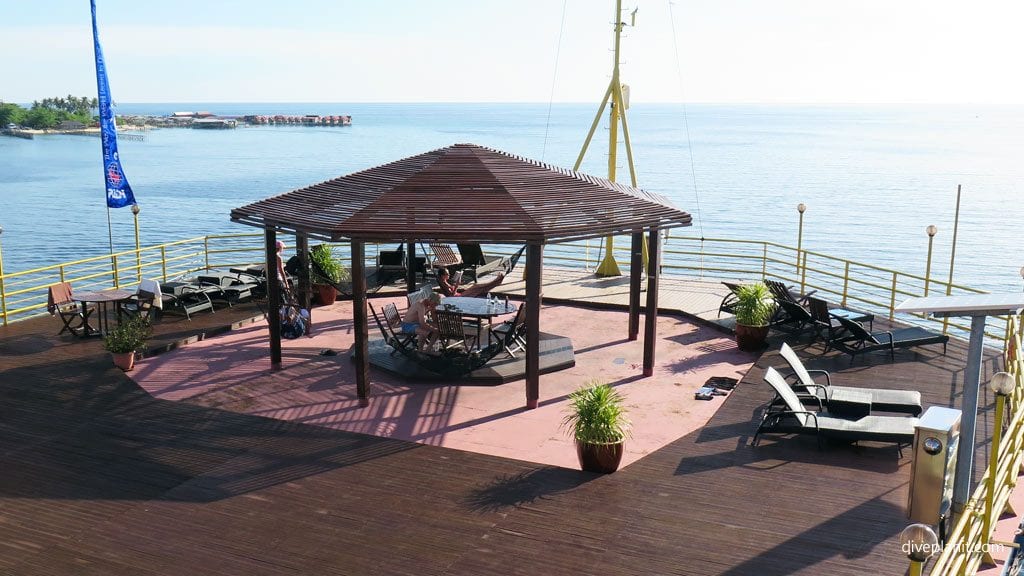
0;233;1009;347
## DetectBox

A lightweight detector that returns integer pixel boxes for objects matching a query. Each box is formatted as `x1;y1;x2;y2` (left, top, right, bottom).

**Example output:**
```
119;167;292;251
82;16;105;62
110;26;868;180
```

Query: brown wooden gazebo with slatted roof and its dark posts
231;143;690;408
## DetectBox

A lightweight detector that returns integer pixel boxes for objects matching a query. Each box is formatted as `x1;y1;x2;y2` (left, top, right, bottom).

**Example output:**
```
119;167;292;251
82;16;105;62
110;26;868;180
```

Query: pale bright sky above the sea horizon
0;0;1024;105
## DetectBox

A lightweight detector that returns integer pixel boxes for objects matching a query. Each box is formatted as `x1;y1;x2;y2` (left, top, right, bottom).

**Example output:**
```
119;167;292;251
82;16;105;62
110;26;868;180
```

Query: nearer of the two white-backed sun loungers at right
753;367;918;449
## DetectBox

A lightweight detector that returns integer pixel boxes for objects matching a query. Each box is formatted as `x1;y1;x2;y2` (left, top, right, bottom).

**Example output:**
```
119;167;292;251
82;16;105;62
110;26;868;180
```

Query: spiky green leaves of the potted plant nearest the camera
562;380;630;444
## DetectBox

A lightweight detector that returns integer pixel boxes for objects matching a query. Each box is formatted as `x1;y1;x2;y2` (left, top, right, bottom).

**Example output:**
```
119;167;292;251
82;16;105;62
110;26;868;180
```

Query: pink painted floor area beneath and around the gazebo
131;299;756;467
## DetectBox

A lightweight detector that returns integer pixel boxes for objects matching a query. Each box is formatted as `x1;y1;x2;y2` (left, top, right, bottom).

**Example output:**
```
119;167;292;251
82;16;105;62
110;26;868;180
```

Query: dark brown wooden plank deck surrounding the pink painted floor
0;279;995;576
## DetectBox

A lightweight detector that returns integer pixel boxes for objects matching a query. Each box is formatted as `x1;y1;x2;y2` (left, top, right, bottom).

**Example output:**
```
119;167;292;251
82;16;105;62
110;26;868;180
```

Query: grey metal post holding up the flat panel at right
947;316;987;513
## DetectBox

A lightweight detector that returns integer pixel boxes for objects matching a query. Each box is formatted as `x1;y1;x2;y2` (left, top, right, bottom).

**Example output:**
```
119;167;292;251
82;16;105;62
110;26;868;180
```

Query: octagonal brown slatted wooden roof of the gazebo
231;143;690;243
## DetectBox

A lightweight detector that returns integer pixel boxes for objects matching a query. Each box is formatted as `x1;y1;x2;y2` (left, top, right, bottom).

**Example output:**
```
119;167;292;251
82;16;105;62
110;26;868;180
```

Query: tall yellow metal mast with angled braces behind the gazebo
572;0;647;276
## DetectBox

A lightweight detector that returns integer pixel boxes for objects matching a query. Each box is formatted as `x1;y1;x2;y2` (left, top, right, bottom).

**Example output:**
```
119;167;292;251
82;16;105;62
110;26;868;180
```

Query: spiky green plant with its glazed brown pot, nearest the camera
562;381;630;474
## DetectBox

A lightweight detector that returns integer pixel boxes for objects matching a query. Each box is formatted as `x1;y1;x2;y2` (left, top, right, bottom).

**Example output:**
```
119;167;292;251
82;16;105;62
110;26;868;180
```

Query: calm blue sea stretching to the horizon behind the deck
0;102;1024;291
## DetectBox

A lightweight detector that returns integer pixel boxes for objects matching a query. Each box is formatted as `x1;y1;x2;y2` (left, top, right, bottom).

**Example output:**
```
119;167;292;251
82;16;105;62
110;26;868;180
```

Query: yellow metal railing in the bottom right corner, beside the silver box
929;316;1024;576
